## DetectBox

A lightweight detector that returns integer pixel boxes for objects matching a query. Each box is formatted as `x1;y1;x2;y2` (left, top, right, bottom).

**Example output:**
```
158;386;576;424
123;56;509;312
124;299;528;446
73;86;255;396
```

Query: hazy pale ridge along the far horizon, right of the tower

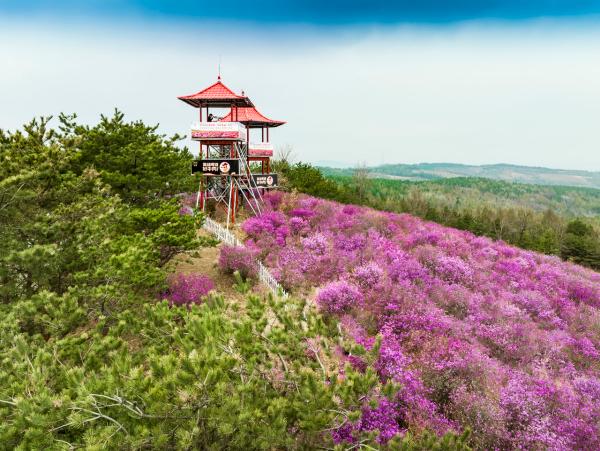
322;163;600;189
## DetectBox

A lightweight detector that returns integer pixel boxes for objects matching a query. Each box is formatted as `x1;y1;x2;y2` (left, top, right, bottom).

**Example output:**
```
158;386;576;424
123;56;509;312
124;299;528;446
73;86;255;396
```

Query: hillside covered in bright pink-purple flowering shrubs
242;192;600;449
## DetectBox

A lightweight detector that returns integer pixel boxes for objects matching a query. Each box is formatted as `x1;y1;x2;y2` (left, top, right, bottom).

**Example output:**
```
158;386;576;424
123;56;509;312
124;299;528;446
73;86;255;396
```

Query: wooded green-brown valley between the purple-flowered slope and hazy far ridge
276;161;600;270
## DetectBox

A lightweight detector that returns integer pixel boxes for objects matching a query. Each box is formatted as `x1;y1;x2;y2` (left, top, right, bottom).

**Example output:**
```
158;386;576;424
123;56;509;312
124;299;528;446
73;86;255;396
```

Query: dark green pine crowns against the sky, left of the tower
0;110;193;208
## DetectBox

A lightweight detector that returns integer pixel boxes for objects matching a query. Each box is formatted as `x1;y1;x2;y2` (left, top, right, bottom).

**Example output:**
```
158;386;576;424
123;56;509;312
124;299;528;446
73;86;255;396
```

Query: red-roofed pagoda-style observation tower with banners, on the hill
178;75;285;227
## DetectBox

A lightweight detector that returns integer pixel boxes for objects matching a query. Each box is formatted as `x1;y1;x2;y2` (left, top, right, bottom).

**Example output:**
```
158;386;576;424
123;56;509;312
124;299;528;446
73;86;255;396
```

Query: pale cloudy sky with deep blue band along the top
0;0;600;171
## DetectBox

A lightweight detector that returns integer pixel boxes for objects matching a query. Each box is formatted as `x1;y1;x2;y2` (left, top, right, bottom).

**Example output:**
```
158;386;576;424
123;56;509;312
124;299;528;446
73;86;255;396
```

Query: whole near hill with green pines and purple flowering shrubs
0;112;600;450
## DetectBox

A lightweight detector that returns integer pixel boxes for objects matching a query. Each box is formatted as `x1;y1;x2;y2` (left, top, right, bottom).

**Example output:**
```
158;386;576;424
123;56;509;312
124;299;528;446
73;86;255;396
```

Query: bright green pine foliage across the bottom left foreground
0;290;342;449
